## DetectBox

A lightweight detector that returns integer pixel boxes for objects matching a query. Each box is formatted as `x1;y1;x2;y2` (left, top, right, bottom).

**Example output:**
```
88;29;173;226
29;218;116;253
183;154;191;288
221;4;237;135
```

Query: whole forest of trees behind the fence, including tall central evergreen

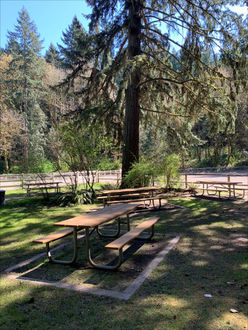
0;0;248;179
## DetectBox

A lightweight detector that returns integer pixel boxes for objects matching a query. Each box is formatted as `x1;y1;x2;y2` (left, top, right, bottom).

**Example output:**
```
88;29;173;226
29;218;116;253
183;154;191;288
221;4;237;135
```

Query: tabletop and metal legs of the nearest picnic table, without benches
53;203;139;269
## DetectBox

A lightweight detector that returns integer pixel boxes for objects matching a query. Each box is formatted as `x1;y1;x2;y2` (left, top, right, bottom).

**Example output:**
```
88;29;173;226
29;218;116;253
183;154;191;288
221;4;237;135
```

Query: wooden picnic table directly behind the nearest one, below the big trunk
97;187;164;208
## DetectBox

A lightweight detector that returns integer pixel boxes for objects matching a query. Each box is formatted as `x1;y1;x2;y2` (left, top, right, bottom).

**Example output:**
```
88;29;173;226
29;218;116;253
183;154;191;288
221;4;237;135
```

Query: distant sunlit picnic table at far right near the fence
196;180;241;198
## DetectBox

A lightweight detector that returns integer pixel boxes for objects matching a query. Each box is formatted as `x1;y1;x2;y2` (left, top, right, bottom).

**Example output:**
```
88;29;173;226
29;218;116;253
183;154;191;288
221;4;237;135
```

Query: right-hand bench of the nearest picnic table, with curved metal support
86;217;159;270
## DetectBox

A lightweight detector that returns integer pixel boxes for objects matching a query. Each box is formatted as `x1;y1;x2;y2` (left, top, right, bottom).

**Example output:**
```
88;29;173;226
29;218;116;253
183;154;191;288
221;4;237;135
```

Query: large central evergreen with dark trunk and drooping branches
59;0;244;179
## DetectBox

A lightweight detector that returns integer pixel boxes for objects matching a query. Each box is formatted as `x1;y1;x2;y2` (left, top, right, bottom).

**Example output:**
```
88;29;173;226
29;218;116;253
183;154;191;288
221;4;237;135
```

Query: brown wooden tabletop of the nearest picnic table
54;203;140;228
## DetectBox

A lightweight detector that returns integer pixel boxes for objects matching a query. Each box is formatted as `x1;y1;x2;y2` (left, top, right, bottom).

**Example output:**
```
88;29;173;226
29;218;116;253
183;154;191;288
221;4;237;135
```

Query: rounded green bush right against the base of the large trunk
122;159;156;188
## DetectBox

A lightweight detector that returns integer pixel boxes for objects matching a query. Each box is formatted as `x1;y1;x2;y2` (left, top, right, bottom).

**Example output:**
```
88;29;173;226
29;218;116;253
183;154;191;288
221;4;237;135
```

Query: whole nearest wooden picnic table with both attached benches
34;203;158;270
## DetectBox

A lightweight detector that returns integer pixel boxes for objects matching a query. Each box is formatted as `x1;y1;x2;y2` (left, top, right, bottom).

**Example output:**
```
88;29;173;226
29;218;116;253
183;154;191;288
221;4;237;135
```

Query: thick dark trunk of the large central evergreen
122;0;141;177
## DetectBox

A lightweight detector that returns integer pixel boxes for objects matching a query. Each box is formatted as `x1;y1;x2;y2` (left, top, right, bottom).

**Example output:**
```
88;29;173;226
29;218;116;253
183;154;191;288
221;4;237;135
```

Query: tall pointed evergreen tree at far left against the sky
7;8;45;172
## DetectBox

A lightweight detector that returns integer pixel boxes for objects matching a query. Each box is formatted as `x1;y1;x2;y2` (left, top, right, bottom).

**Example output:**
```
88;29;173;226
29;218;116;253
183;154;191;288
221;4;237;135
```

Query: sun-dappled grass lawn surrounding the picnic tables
0;192;248;330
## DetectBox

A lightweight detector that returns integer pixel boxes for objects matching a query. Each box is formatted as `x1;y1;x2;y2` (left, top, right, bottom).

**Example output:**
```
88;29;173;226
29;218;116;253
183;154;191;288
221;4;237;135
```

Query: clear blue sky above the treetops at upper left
0;0;90;54
